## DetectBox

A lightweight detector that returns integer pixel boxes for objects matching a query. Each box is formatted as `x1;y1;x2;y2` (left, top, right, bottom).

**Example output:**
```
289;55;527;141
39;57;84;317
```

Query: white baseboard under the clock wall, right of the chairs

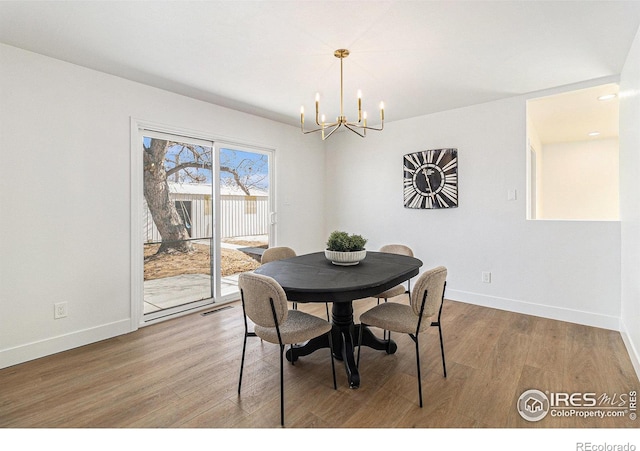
445;289;620;330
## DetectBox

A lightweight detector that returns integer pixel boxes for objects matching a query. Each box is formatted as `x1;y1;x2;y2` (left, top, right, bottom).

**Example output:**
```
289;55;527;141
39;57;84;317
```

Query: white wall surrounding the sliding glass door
0;45;325;368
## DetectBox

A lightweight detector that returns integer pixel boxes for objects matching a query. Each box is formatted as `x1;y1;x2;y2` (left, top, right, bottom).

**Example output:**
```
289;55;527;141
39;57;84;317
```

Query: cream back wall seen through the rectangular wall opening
537;138;620;221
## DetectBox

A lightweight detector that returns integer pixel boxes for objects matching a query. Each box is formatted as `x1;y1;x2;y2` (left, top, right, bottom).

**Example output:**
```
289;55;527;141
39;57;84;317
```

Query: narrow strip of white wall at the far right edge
620;25;640;374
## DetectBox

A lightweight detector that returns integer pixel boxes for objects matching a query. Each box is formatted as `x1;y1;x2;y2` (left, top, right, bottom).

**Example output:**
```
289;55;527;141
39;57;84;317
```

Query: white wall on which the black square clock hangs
325;88;620;329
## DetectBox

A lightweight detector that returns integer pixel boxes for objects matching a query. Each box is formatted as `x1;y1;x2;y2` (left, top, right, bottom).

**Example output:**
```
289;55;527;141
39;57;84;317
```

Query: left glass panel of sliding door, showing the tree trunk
142;132;214;320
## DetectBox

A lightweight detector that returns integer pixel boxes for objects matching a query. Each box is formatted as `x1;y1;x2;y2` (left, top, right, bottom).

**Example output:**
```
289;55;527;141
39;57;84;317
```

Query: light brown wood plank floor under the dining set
0;300;640;428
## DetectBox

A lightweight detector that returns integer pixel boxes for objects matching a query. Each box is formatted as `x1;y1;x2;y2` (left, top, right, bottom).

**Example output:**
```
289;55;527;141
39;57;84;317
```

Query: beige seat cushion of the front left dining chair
254;310;331;344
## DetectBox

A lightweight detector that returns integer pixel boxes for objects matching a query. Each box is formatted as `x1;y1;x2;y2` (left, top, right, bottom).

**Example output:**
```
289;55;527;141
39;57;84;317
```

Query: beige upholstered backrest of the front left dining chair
238;272;289;327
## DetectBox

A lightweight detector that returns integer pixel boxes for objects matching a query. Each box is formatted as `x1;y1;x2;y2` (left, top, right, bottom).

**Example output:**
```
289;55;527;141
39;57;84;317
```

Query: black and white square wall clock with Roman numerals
403;149;458;208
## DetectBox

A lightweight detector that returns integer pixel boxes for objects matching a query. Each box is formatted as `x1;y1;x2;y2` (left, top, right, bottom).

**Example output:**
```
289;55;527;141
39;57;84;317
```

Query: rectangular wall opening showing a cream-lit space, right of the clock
526;83;620;221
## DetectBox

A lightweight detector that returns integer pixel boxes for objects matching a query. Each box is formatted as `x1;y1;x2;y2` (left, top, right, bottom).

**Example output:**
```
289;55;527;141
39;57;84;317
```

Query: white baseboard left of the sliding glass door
0;319;132;369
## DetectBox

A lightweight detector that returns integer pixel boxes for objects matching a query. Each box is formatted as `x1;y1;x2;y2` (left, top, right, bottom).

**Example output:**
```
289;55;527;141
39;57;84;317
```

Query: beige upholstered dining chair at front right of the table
357;266;447;407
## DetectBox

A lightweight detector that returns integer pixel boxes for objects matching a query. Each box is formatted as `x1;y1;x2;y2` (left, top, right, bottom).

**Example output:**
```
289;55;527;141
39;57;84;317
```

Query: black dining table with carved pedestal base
255;251;422;388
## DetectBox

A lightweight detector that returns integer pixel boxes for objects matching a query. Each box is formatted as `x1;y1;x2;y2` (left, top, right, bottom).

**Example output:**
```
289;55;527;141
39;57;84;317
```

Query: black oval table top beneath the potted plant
255;251;422;302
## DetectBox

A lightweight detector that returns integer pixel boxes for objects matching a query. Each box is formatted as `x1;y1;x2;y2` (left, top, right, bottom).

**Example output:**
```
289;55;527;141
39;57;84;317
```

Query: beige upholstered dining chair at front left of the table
238;272;338;426
